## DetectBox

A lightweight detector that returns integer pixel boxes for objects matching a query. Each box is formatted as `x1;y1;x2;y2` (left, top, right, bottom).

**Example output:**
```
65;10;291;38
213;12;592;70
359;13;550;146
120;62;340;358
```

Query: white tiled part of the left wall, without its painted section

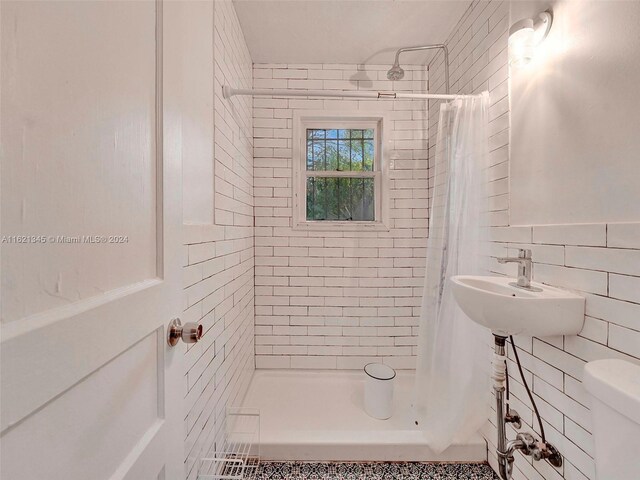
182;1;254;479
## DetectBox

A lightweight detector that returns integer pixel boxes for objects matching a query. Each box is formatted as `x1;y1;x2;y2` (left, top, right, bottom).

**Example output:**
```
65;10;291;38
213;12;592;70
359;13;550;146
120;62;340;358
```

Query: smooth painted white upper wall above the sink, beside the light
510;0;640;225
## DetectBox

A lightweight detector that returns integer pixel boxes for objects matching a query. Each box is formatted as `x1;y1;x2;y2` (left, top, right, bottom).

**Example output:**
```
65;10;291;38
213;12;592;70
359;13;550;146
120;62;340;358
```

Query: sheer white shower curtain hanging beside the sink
413;93;491;453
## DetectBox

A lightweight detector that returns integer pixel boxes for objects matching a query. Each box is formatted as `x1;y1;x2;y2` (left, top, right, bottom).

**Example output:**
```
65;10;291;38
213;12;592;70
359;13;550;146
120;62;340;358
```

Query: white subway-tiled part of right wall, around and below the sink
429;1;640;480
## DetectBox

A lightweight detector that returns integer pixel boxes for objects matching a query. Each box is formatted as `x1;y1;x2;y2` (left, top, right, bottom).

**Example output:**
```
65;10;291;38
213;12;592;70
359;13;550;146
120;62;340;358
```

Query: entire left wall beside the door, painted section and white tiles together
182;1;254;479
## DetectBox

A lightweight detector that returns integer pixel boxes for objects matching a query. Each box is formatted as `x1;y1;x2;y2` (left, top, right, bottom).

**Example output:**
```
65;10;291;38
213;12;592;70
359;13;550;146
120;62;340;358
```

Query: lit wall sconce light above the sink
509;11;553;67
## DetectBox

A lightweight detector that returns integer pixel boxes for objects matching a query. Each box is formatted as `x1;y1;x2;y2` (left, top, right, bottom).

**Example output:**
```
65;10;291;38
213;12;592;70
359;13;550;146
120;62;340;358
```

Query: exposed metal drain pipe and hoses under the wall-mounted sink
491;335;562;480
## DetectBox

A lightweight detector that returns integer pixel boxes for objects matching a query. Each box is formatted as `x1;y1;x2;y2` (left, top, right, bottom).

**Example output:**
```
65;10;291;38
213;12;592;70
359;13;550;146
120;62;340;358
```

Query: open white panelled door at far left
0;1;185;480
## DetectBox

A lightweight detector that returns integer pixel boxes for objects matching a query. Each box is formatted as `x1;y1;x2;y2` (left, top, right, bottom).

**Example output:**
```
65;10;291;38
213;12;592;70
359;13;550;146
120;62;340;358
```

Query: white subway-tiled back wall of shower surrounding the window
253;64;428;369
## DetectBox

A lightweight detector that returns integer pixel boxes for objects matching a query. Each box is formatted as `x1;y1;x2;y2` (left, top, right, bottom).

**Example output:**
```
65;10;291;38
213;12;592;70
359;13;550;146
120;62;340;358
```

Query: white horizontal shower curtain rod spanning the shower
222;85;473;100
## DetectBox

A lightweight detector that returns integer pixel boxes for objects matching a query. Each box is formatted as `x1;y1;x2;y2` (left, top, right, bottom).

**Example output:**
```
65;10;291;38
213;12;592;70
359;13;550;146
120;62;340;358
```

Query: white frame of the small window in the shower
292;110;390;231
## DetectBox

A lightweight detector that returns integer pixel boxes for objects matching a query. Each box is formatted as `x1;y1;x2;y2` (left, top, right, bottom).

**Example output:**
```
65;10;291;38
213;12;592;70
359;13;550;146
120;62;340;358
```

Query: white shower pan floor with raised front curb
243;370;487;462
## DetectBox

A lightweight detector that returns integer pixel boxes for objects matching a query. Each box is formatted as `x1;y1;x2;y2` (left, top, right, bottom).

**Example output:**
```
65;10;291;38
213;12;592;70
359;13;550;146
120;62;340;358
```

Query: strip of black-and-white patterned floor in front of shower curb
248;462;498;480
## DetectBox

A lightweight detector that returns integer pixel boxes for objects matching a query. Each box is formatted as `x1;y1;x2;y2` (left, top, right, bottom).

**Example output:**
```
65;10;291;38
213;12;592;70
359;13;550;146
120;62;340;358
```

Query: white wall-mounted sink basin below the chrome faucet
451;275;585;337
